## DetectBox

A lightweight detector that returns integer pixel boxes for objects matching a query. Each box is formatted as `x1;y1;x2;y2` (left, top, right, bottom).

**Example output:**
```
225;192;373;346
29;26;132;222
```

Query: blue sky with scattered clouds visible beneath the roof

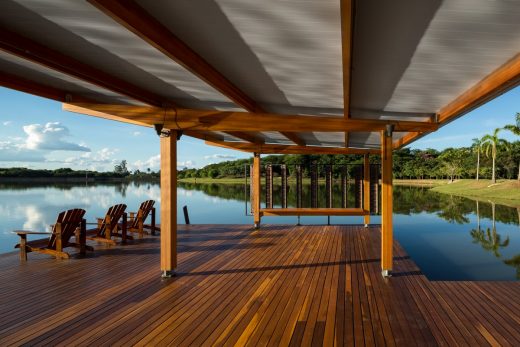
0;87;520;171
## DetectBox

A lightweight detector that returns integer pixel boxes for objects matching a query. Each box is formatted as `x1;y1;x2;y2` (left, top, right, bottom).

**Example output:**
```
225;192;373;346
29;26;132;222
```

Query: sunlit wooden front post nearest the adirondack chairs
161;131;177;277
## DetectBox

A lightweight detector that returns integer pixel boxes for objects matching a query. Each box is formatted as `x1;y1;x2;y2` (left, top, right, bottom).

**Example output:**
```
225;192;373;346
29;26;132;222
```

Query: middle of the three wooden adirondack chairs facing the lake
87;204;132;245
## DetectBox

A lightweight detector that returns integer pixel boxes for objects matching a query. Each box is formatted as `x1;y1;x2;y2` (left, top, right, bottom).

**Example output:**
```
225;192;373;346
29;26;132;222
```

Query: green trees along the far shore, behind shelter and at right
178;113;520;182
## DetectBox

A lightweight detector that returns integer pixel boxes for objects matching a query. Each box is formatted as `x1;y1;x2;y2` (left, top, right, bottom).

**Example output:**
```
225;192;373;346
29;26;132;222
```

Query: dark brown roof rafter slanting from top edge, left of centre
88;0;305;145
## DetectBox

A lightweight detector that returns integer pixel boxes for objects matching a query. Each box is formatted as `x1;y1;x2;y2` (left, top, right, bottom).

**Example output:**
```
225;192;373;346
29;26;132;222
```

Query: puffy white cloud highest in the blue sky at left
23;122;90;152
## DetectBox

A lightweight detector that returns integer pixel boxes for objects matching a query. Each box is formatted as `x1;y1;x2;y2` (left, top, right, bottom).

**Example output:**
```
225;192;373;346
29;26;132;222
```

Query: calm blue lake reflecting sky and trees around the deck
0;183;520;280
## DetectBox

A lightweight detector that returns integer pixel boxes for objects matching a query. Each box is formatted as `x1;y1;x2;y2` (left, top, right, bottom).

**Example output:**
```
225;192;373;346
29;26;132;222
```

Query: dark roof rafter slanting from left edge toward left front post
0;27;164;106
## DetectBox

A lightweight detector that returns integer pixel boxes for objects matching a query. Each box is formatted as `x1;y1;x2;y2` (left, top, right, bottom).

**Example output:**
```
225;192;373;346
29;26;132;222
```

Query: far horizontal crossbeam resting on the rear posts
206;141;380;154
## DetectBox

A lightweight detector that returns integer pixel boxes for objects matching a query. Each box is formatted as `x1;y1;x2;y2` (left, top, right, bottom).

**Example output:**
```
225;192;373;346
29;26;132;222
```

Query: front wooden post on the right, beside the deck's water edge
381;129;393;277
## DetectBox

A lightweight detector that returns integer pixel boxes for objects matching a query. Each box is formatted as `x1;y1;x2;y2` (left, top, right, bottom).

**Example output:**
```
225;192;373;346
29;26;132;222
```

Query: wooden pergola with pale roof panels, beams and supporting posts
0;0;520;276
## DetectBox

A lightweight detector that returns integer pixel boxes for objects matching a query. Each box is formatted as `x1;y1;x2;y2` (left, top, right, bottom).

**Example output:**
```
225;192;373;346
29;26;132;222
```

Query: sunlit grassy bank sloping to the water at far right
432;180;520;207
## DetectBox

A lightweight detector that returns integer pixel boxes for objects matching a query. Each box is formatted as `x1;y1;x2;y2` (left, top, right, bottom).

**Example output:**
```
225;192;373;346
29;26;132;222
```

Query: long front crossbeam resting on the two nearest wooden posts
63;103;437;133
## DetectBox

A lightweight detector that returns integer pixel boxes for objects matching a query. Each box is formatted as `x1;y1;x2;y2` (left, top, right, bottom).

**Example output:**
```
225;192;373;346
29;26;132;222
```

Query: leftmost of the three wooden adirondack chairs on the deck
14;208;90;261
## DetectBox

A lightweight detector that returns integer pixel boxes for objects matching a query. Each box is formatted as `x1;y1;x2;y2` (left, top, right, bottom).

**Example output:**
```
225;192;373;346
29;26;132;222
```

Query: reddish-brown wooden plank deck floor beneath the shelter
0;225;520;346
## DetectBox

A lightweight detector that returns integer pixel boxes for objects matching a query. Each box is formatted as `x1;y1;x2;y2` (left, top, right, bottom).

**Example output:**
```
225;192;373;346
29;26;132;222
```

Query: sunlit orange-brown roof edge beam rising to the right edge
394;53;520;148
